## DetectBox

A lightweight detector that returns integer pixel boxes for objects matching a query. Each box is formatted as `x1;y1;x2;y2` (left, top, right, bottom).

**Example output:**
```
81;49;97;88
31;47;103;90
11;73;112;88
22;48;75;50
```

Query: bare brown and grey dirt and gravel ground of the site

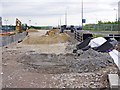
1;30;118;89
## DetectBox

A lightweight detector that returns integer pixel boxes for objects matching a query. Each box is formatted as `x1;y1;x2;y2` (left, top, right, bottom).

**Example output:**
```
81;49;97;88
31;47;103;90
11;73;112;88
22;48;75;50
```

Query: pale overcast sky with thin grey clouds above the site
0;0;120;26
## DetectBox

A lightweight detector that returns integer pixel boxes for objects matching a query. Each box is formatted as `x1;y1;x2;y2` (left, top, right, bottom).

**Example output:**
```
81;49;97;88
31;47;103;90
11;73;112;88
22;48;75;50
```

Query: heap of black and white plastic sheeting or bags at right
73;37;118;53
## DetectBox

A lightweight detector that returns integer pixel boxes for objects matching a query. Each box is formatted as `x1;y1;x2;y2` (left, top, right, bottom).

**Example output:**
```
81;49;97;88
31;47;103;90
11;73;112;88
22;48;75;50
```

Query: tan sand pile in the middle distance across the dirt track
23;29;70;44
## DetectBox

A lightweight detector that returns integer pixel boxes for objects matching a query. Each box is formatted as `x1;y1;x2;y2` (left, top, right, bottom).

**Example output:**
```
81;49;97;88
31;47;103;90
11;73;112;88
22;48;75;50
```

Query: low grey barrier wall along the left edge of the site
0;32;27;47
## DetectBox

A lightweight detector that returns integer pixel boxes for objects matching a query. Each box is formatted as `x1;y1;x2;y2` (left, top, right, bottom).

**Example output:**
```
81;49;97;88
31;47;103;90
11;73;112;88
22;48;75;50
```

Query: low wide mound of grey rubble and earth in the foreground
17;49;114;74
